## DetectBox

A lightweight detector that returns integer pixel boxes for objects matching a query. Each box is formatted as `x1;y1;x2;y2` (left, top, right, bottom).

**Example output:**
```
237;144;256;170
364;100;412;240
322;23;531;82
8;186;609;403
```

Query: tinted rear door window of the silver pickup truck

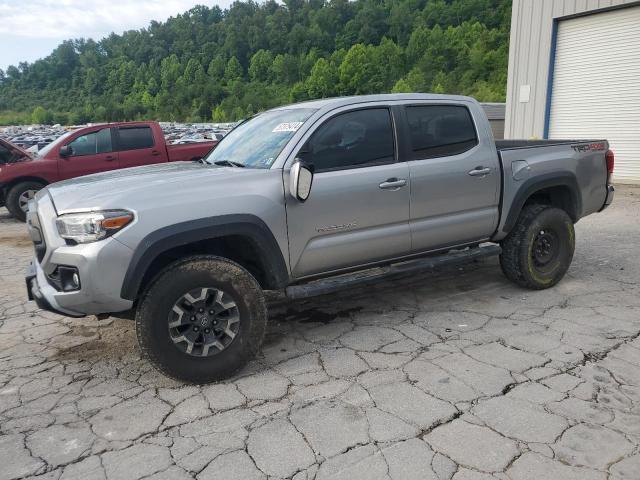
406;105;478;160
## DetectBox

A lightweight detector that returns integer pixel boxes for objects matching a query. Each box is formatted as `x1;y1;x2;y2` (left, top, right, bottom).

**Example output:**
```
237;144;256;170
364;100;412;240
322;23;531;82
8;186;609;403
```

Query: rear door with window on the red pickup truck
116;125;167;168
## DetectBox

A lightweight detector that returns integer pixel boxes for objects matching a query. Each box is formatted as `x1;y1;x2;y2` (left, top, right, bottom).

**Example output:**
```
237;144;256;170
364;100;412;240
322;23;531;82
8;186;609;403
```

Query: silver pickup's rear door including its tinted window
404;103;500;253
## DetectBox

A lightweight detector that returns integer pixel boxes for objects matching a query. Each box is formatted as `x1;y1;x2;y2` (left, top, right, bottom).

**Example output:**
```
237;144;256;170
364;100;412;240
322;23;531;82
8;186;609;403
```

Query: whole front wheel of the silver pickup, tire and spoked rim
135;256;267;384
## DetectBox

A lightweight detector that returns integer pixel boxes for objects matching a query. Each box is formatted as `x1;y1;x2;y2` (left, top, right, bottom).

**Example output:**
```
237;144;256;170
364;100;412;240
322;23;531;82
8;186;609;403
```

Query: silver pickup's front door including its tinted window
286;106;411;278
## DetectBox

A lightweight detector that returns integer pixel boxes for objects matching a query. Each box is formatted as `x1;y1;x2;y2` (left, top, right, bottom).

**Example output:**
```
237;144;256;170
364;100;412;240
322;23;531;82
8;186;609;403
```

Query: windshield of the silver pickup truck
205;108;315;168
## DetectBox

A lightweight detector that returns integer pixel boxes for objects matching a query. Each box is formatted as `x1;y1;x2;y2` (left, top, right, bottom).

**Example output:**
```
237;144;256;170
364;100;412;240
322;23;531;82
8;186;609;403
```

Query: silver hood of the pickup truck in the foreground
47;162;265;213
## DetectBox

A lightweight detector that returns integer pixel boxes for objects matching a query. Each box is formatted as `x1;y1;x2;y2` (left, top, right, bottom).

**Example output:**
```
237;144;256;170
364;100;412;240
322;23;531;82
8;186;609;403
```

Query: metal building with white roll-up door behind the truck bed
505;0;640;183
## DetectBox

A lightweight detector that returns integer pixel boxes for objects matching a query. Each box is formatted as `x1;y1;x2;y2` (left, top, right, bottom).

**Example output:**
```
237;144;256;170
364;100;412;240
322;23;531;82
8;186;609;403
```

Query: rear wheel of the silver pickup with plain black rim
500;205;575;290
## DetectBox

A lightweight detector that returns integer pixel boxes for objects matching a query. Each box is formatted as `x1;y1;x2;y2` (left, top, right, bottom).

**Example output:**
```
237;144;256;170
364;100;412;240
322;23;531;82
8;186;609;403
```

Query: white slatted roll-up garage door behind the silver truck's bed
549;6;640;182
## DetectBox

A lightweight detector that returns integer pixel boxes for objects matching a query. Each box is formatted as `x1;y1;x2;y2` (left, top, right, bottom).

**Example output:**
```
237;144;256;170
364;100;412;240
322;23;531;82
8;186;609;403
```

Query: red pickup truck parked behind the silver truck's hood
0;122;217;220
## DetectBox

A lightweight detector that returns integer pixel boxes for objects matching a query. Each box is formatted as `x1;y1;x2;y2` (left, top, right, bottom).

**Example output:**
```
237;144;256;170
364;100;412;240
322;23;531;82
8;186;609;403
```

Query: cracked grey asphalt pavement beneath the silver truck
0;187;640;480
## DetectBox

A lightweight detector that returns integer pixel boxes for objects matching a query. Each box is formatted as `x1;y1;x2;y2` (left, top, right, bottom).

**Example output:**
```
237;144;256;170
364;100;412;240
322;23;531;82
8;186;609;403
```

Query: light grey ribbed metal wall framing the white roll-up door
505;0;640;138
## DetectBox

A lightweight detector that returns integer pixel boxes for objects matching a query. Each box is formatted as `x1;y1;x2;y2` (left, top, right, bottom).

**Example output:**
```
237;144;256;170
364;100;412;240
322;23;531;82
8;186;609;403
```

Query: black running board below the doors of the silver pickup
285;244;502;298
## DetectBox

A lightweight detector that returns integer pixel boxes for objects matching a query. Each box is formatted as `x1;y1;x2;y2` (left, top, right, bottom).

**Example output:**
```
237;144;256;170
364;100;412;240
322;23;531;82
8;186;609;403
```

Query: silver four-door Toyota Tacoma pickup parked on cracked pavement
26;94;613;383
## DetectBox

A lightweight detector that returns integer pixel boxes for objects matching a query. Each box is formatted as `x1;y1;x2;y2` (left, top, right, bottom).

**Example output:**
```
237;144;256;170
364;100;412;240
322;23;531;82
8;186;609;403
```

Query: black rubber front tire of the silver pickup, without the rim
135;255;267;384
